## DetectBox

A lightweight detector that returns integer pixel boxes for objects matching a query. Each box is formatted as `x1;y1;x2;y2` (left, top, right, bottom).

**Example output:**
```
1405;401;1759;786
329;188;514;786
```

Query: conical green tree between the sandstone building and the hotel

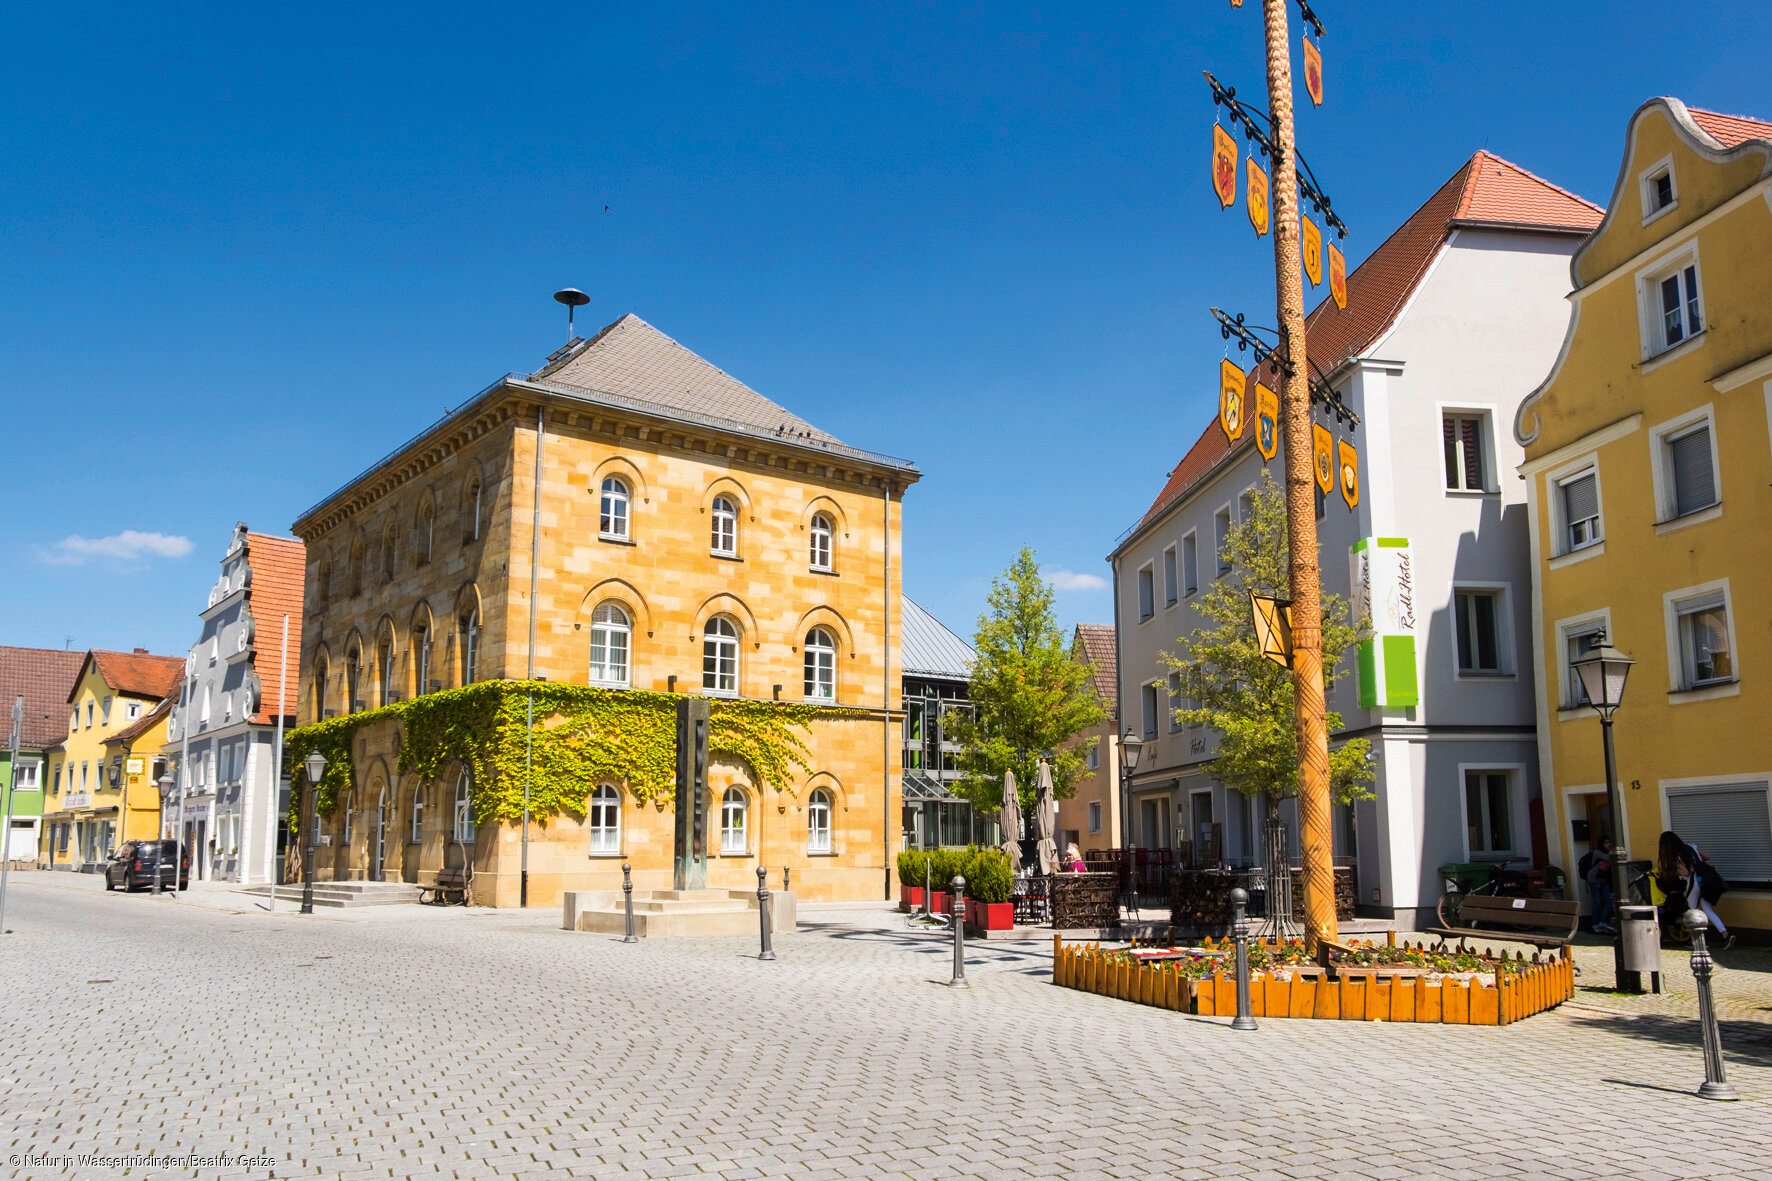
946;548;1106;810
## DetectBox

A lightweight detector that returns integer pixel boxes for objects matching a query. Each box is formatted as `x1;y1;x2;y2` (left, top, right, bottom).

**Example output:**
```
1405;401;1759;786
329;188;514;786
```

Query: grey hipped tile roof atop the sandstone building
530;312;838;443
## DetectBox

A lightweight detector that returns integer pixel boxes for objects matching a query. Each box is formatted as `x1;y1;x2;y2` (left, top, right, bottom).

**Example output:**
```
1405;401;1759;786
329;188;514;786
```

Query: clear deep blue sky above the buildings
0;0;1772;653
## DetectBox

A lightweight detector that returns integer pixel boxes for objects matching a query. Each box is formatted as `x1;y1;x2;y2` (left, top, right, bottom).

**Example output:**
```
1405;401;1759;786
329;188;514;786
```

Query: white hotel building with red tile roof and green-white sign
1109;153;1602;926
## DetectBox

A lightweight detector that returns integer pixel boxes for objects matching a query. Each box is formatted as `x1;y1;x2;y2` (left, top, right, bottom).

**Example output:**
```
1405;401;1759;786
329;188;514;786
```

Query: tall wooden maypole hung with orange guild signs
1207;0;1359;947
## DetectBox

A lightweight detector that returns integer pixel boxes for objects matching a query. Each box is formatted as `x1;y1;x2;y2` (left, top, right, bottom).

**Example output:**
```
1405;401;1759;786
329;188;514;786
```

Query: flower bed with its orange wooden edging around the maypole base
1053;936;1575;1025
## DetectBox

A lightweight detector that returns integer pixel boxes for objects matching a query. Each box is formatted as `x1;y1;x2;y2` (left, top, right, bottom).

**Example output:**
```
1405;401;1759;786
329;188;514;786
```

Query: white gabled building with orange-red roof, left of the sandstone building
165;523;307;881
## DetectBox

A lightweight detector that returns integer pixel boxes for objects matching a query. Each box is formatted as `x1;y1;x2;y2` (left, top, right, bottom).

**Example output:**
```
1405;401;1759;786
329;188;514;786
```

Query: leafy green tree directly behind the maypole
1164;470;1373;814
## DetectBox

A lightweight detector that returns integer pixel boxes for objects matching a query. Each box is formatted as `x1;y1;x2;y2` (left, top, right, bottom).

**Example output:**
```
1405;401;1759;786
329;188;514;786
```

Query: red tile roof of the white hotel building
1132;151;1605;534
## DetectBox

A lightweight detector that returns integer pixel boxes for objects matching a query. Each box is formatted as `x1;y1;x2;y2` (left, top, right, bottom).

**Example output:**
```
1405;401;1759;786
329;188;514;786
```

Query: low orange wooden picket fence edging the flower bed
1053;935;1575;1025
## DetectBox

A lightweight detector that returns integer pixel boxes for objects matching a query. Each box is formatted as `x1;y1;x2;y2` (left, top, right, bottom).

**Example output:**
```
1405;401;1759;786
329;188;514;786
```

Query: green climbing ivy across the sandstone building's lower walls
285;681;868;828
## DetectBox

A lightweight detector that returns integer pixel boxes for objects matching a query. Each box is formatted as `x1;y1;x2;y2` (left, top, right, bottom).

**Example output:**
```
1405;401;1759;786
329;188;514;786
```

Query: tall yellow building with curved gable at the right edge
1515;99;1772;927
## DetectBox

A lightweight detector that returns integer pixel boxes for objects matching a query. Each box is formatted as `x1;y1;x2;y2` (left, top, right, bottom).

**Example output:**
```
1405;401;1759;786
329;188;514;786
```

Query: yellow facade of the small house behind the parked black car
37;656;165;869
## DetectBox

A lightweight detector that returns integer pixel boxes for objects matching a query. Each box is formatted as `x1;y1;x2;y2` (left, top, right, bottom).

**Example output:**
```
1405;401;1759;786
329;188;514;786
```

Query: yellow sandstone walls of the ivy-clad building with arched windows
294;312;916;906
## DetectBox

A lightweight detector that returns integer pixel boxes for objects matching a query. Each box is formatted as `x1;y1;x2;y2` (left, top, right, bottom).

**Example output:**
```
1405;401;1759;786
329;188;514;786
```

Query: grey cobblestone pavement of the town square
0;874;1772;1181
